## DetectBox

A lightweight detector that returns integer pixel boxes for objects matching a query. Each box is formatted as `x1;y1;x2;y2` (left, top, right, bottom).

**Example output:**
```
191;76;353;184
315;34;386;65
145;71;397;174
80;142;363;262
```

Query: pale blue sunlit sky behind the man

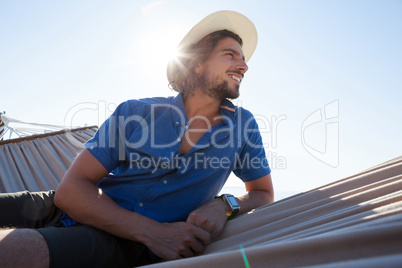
0;0;402;197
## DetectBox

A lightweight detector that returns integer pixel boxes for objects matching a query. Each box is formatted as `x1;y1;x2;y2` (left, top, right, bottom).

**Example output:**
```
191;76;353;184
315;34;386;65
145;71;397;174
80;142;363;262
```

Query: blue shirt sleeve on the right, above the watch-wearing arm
233;109;271;182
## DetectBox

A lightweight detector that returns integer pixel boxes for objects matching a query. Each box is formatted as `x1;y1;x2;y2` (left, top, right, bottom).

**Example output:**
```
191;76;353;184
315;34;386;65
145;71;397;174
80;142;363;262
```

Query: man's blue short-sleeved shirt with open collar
62;94;270;226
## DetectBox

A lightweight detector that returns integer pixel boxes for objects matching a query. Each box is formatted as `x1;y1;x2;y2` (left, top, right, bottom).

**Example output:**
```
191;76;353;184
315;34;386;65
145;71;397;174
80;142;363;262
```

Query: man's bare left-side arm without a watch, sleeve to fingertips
55;149;210;260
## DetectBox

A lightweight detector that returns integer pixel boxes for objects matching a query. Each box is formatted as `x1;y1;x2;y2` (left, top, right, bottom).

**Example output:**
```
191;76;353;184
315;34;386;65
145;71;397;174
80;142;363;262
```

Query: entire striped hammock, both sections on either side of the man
0;120;402;268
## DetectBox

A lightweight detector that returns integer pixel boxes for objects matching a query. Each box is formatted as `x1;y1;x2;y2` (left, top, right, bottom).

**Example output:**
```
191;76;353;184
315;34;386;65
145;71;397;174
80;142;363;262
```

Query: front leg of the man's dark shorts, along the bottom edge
37;225;151;268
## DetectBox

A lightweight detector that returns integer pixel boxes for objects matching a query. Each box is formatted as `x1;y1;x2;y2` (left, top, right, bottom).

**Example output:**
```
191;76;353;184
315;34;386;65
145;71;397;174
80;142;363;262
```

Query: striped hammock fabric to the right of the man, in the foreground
147;157;402;268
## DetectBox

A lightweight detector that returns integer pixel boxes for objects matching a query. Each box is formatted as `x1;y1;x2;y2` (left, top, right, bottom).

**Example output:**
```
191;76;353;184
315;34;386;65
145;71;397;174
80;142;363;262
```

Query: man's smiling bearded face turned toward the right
197;37;248;100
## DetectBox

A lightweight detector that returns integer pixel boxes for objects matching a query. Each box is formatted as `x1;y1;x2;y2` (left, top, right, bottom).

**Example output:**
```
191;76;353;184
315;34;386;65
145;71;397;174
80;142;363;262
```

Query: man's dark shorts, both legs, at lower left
0;191;151;268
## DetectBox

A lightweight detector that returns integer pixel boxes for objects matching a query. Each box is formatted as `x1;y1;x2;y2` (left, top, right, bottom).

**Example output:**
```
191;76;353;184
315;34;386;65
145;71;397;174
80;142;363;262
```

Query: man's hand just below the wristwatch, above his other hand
187;198;228;240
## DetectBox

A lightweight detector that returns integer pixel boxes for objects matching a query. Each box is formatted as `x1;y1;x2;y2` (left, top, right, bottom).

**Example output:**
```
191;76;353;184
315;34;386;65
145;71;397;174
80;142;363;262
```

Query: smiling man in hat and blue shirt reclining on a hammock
0;11;273;267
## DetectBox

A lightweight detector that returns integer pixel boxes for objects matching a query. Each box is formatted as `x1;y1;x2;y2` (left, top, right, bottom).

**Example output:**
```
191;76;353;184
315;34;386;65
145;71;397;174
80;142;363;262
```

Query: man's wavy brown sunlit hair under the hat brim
169;30;243;96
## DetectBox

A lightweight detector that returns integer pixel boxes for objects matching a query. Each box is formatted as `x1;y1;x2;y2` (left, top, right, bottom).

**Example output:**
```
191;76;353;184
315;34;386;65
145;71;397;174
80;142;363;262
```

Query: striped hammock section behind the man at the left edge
0;127;97;193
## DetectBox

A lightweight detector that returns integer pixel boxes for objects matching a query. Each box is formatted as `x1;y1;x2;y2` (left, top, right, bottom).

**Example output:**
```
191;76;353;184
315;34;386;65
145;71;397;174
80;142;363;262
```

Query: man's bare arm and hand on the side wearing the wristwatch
187;174;274;240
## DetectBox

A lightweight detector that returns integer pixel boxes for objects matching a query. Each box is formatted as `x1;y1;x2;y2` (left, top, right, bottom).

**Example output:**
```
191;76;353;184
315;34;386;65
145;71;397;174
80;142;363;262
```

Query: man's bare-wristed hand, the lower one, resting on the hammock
144;222;211;260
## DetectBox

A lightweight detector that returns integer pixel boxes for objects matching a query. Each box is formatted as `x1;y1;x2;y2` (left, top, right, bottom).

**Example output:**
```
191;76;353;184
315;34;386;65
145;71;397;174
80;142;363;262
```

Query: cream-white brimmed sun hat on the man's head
167;10;258;82
